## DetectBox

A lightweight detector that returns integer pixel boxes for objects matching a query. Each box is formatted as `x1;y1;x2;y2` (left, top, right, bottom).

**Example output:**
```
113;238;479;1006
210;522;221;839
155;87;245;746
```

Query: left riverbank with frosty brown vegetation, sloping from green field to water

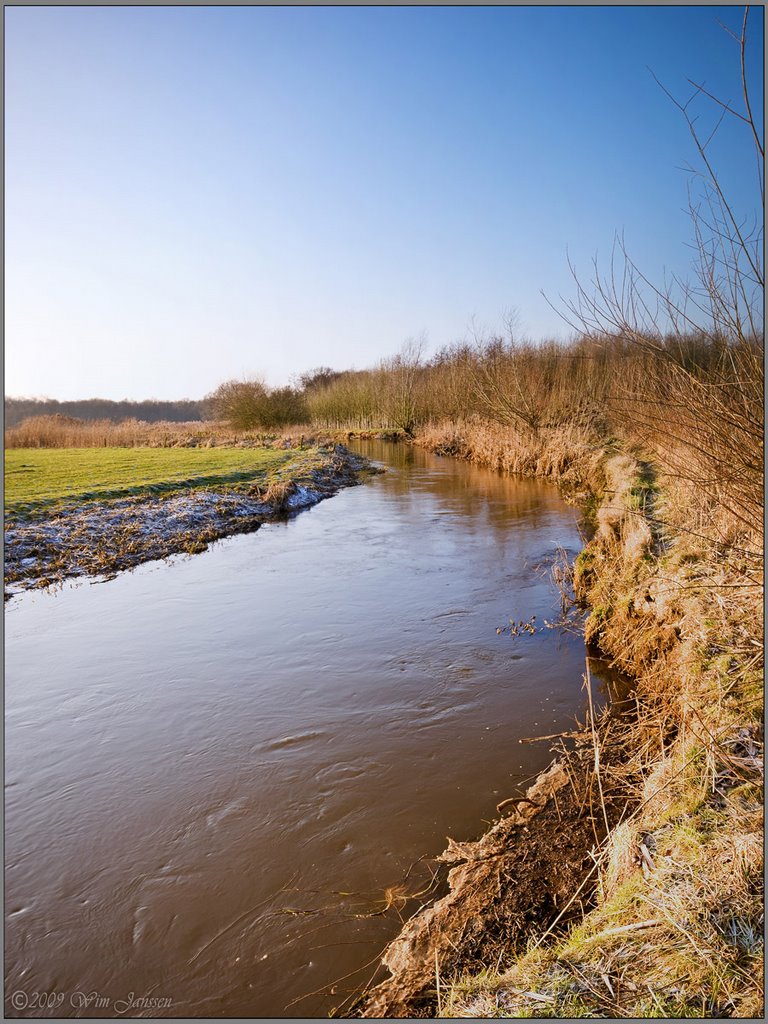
5;445;371;599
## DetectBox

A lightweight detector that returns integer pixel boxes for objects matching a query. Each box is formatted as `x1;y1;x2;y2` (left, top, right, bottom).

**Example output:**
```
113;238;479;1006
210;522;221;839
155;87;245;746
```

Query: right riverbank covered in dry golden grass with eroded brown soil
357;422;763;1018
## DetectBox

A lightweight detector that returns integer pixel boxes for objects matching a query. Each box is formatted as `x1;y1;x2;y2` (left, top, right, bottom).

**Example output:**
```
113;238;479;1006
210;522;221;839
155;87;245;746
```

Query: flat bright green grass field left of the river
5;447;303;516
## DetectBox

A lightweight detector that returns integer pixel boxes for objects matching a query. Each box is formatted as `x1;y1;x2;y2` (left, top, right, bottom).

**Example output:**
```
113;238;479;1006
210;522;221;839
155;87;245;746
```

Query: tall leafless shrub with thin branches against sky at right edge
561;7;765;547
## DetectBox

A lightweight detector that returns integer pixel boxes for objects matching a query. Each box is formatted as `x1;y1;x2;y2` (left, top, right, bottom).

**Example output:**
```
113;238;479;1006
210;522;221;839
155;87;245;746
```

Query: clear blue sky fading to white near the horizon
4;6;763;400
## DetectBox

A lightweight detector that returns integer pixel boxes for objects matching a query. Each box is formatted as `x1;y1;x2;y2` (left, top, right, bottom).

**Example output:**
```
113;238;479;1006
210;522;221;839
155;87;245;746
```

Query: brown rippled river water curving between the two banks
5;442;618;1018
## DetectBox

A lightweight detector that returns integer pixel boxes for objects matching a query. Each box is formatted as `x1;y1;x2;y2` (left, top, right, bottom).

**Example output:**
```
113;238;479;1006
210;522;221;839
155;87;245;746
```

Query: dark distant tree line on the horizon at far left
5;398;204;429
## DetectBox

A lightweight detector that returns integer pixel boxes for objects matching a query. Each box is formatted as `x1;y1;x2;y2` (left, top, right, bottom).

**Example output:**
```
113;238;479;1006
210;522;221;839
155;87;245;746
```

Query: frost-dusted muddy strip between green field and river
4;444;374;600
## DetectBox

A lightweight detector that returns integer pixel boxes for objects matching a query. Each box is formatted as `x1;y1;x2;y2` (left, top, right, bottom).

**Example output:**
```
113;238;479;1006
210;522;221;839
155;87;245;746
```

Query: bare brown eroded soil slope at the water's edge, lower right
354;733;627;1018
